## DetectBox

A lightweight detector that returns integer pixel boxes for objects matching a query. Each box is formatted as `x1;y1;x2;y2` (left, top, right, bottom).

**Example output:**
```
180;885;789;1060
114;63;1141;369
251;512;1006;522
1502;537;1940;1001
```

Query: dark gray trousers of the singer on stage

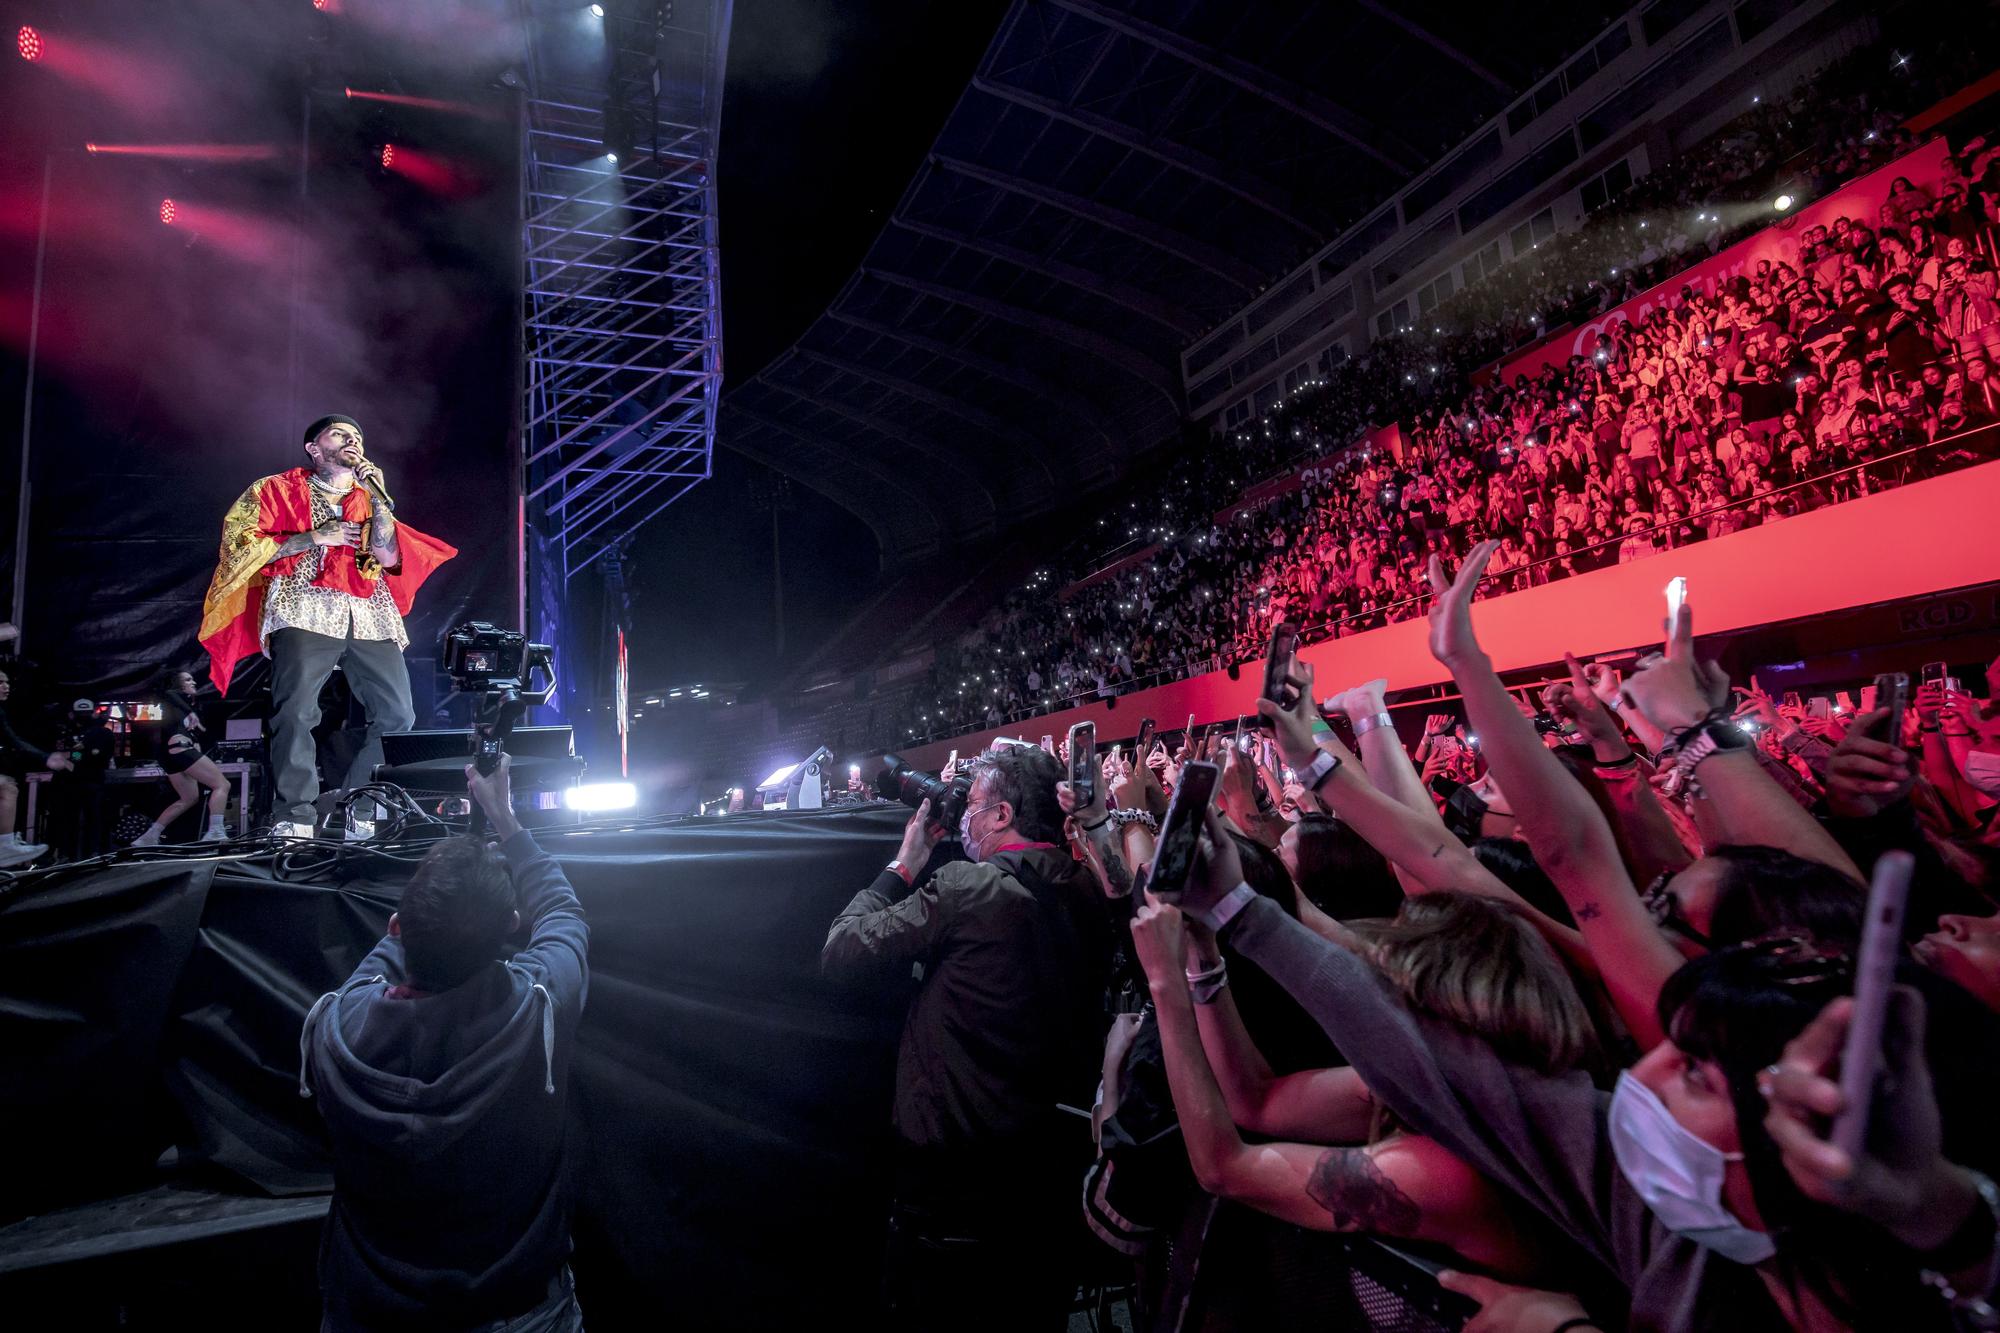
270;628;416;823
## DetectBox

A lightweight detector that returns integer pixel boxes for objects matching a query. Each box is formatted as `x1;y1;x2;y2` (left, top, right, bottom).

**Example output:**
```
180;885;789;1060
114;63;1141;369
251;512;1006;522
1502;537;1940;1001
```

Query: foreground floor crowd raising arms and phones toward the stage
1016;564;2000;1333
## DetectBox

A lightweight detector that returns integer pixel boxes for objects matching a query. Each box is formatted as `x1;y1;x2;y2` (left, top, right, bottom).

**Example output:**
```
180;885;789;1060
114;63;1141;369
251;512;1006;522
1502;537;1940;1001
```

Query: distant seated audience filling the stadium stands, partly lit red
898;31;2000;741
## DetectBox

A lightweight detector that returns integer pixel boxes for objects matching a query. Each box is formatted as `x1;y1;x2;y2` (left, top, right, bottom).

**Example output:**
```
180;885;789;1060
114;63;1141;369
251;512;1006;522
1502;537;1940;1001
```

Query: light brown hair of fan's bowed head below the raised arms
1348;893;1600;1075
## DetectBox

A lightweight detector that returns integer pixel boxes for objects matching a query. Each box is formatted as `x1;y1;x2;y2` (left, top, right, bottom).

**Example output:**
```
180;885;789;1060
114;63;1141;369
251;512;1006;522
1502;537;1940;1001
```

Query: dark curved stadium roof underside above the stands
718;0;1602;564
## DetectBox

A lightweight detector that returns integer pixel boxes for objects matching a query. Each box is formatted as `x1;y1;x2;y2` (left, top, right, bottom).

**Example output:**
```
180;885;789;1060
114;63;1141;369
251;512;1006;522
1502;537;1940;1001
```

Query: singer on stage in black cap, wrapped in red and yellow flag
200;414;458;837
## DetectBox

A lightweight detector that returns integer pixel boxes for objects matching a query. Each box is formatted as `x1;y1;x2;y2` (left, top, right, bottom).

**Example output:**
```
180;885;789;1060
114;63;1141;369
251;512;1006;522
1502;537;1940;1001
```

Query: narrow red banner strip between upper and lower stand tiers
1500;138;1946;384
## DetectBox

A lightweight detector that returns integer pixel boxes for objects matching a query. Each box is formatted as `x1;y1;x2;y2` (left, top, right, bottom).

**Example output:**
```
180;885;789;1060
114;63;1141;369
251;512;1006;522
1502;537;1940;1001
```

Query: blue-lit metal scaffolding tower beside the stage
520;0;730;716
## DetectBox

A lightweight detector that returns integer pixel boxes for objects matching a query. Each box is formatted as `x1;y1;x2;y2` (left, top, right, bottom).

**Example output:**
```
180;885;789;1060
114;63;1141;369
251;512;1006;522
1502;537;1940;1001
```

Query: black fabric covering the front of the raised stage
0;805;1480;1333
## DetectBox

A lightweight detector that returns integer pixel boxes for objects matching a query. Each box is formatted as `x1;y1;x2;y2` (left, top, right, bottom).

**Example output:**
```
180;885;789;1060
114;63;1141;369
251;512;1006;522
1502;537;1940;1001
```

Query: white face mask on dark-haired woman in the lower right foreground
1610;1073;1778;1263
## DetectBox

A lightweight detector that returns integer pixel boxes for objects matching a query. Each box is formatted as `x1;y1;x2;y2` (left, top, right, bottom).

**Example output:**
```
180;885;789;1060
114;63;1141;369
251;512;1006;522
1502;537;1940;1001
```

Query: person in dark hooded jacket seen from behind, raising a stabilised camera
298;759;590;1333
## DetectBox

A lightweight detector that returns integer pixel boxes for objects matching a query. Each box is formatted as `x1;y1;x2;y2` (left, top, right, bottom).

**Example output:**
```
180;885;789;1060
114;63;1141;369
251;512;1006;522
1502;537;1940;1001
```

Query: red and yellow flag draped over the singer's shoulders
200;468;458;695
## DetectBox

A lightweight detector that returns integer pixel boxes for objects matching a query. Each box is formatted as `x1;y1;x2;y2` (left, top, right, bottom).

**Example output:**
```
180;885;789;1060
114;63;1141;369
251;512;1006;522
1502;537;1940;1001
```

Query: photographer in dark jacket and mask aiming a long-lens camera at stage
820;745;1110;1331
